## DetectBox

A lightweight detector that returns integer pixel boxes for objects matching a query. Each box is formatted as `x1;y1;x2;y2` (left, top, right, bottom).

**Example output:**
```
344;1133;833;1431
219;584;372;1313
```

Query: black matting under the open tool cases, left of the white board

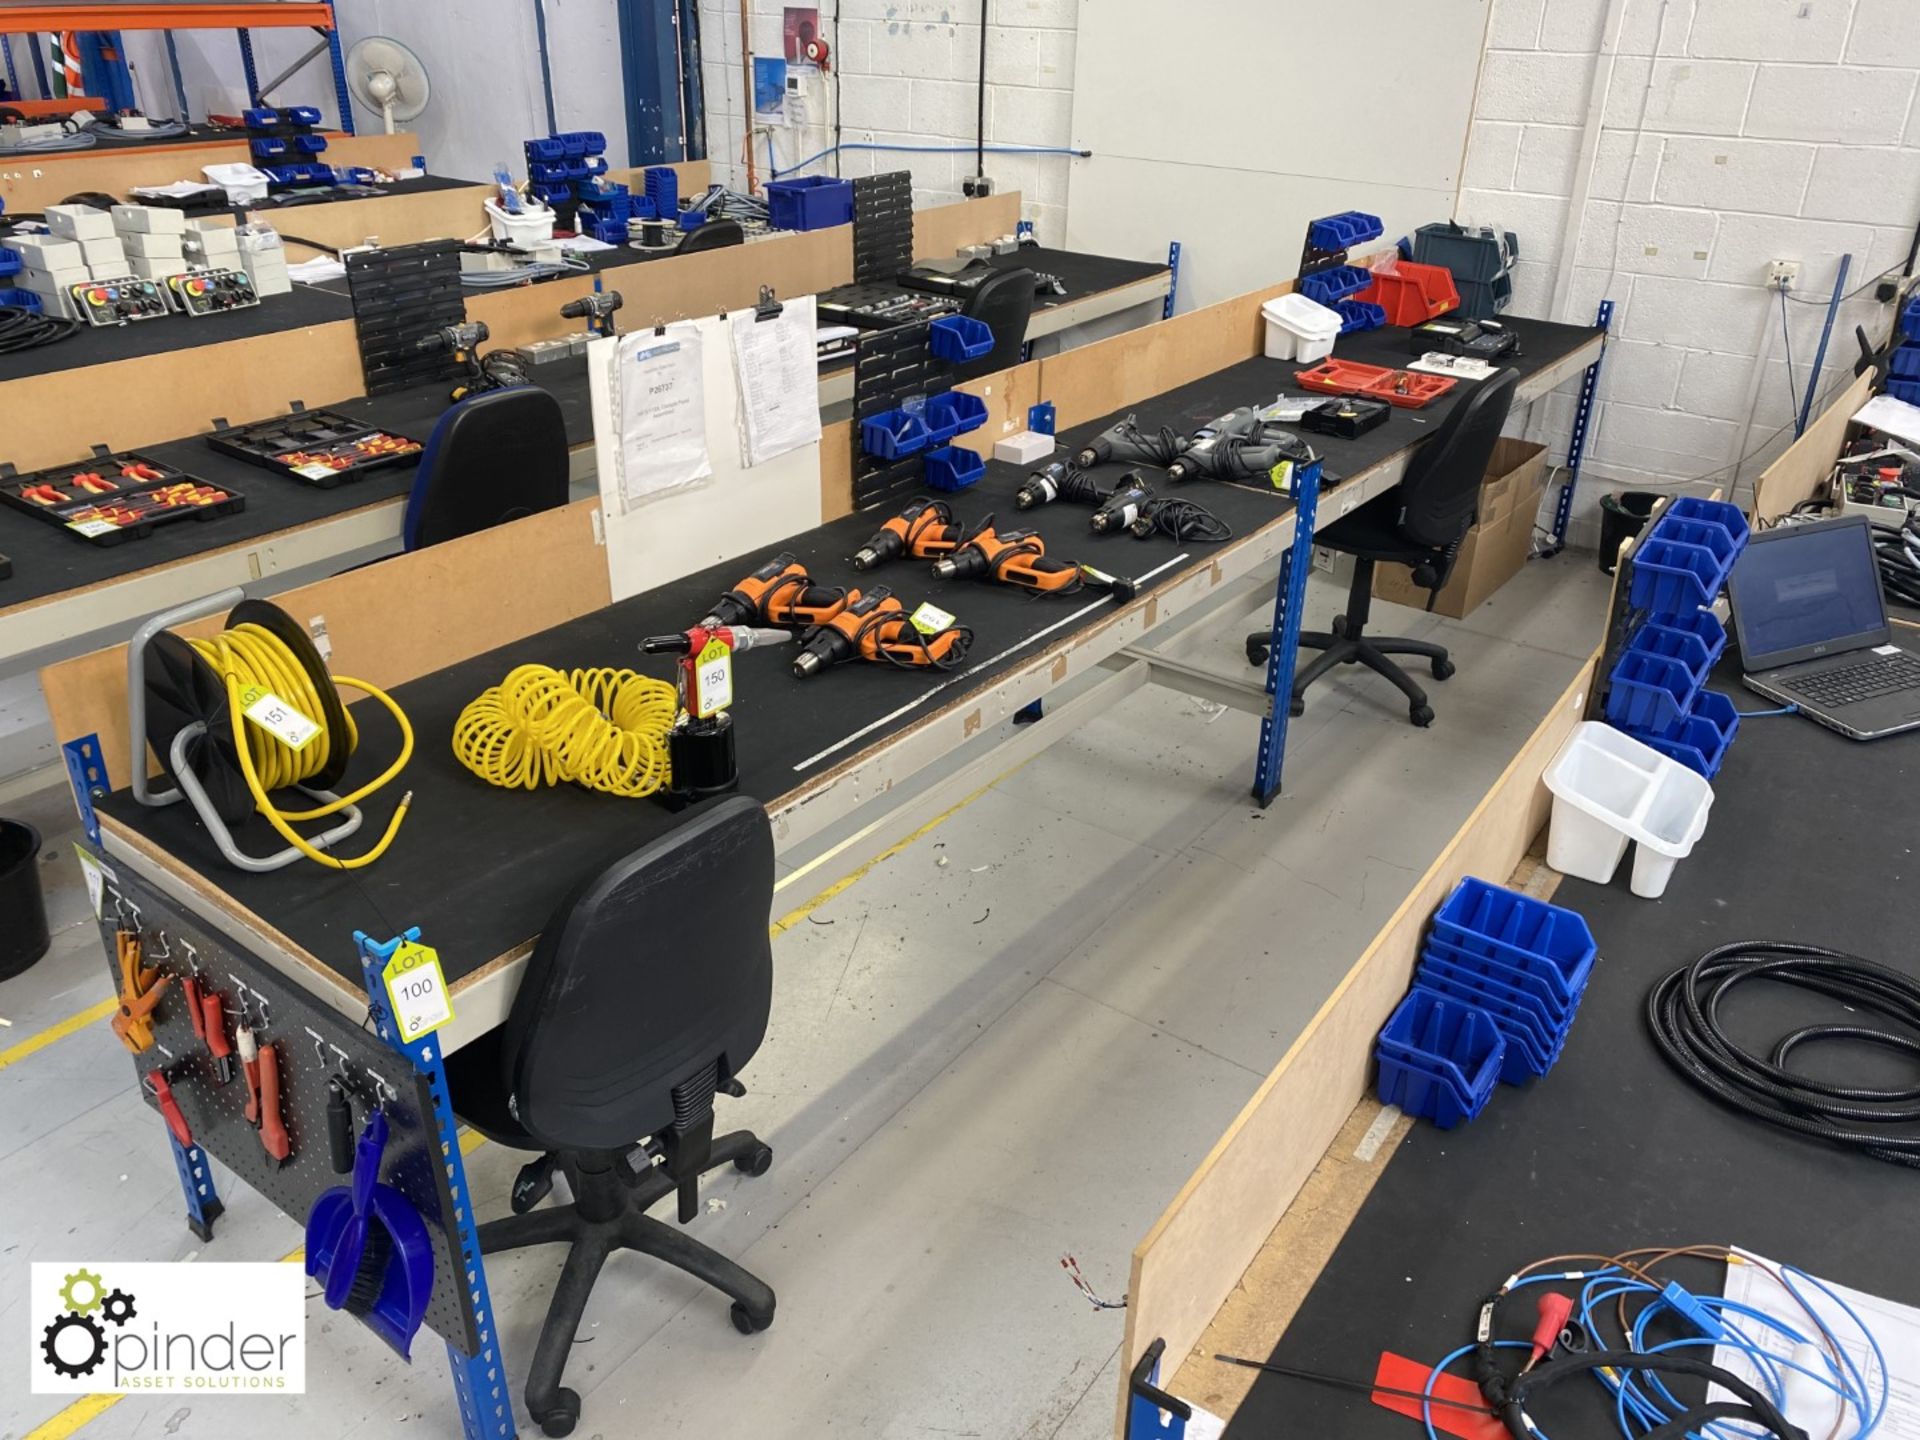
0;359;593;607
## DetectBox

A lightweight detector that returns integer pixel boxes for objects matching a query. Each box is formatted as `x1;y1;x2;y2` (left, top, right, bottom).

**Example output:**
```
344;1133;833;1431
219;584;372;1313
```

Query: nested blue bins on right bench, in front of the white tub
1375;876;1597;1129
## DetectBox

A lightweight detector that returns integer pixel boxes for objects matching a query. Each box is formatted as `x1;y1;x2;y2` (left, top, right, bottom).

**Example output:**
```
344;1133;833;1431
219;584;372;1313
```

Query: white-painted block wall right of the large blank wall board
1457;0;1920;540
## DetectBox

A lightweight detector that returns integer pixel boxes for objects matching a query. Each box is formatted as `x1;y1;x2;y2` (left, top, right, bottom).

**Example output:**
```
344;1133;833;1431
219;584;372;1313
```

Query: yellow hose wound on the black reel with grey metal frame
188;624;413;870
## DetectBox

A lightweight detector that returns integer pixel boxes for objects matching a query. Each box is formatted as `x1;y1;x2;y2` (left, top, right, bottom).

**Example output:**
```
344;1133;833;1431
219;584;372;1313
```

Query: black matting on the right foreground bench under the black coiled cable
1228;683;1920;1440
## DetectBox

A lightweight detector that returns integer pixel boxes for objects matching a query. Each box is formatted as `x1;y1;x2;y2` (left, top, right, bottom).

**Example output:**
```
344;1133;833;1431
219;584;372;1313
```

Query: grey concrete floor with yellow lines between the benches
0;555;1607;1440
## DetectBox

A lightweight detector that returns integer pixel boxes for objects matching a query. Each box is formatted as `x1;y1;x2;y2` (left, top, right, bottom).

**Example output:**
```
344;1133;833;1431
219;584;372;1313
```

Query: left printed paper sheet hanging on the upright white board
609;323;712;513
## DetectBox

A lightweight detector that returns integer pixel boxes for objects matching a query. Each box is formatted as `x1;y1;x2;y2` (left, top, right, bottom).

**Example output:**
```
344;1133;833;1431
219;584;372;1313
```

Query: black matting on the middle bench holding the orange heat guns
90;324;1592;983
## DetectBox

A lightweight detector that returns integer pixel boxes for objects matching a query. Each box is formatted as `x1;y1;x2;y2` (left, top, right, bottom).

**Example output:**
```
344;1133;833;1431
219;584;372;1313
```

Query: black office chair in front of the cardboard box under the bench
1246;371;1517;726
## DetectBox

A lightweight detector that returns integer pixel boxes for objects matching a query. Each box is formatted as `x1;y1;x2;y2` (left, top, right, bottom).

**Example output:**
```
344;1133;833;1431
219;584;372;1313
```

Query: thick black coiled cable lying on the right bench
1647;941;1920;1169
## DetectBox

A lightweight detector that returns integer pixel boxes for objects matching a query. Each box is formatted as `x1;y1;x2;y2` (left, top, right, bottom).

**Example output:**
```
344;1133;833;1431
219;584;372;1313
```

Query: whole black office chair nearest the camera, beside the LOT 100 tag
447;795;774;1436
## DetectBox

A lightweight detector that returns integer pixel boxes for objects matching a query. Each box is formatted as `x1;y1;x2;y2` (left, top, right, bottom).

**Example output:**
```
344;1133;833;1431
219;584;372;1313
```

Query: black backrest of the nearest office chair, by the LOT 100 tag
501;795;774;1150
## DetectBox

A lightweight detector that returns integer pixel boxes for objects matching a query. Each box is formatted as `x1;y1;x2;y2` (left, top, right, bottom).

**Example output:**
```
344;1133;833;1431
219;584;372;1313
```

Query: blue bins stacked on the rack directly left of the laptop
1605;497;1749;780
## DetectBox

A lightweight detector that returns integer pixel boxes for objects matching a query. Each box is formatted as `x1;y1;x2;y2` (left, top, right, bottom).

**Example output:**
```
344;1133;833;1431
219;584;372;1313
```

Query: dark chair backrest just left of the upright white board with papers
403;386;568;549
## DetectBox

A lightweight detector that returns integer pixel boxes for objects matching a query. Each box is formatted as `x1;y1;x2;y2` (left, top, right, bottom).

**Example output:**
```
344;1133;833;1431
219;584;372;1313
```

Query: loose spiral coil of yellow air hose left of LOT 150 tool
453;664;680;799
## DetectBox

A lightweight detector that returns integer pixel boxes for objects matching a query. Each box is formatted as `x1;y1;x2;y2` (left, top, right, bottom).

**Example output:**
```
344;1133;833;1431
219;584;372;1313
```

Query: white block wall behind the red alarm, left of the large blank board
701;0;1077;244
